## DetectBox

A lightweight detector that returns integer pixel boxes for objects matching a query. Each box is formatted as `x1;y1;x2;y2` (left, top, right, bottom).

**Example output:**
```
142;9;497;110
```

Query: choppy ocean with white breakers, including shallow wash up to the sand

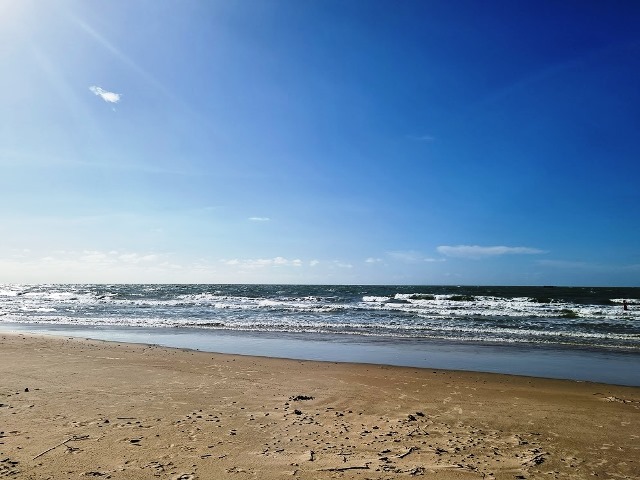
0;285;640;385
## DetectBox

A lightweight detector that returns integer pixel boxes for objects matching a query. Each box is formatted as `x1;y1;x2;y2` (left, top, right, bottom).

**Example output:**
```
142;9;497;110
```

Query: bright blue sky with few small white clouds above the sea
0;0;640;286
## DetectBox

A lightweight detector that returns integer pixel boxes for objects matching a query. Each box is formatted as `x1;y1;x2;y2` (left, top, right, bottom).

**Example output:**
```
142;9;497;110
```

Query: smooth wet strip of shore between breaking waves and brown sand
0;323;640;386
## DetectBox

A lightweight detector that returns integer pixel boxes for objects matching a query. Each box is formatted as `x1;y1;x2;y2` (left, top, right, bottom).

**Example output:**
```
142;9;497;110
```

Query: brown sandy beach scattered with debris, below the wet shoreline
0;334;640;480
